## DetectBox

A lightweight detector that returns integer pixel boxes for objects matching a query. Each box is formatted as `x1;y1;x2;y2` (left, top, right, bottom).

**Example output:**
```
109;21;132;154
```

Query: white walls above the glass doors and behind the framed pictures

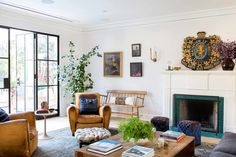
0;8;236;119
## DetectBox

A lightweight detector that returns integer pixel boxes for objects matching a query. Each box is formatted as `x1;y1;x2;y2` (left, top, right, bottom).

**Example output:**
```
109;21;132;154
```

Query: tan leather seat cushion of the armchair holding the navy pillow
78;115;102;124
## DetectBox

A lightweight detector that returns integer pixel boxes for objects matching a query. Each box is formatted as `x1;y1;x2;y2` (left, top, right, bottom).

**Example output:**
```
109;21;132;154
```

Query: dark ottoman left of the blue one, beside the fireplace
151;116;169;131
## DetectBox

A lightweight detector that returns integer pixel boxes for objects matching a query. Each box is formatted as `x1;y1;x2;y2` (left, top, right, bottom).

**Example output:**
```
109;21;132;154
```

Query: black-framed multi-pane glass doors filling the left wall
0;26;59;115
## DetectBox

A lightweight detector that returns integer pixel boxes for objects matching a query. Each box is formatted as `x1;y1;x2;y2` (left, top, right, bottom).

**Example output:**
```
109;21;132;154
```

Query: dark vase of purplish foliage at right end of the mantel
216;41;236;70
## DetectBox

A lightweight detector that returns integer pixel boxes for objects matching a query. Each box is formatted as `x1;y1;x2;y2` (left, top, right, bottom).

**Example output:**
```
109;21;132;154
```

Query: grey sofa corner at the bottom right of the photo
213;132;236;155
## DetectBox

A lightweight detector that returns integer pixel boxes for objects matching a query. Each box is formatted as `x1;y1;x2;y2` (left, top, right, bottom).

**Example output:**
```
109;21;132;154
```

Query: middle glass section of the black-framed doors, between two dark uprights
10;29;34;112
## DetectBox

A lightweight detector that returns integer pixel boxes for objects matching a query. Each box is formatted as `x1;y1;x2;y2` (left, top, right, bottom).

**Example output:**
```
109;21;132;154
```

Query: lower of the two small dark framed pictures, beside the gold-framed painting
130;62;143;77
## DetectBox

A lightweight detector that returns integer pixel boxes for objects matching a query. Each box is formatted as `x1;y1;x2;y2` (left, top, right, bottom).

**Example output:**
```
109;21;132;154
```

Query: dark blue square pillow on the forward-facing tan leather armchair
80;98;98;114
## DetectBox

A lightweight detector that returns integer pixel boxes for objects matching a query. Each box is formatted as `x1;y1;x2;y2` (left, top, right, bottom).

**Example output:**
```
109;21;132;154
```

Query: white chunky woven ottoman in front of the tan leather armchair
75;127;111;148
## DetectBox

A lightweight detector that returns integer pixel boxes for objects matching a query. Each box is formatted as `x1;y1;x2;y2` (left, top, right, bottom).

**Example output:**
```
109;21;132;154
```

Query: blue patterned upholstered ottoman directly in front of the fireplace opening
178;120;201;145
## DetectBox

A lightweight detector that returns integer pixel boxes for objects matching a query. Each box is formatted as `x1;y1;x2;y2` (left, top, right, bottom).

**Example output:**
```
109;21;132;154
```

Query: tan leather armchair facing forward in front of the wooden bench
67;93;111;136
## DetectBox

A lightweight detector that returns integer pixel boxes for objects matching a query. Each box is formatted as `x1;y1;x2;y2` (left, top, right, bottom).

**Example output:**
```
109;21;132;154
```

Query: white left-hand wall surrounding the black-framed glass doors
0;8;82;116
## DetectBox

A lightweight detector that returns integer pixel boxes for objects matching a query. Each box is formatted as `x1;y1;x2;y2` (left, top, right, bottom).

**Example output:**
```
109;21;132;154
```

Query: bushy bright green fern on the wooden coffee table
118;117;155;143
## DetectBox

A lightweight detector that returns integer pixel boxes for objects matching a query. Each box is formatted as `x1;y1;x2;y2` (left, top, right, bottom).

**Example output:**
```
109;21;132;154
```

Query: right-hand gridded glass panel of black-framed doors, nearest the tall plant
36;34;58;110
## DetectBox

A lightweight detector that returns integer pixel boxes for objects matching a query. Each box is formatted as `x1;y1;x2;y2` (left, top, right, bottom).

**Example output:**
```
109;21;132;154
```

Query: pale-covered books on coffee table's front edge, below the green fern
122;145;154;157
